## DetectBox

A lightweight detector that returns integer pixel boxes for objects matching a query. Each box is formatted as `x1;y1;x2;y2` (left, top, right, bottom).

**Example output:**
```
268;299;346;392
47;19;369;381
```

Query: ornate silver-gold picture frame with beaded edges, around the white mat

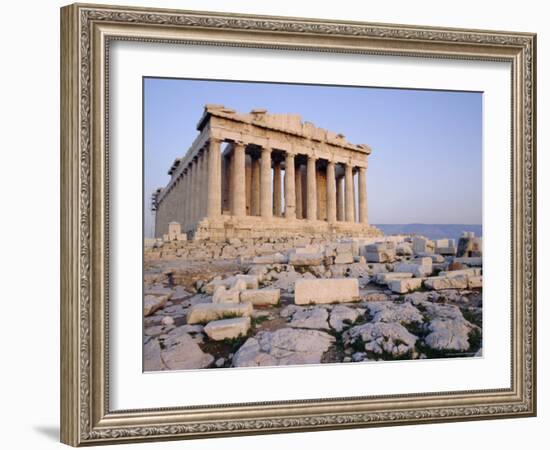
61;4;536;446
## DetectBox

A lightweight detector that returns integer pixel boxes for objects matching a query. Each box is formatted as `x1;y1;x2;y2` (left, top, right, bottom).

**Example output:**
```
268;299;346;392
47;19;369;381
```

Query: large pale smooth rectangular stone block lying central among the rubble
294;278;360;305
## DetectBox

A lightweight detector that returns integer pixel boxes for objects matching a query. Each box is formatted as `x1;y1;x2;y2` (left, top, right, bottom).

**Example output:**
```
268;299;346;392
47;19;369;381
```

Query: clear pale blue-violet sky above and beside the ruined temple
144;78;482;235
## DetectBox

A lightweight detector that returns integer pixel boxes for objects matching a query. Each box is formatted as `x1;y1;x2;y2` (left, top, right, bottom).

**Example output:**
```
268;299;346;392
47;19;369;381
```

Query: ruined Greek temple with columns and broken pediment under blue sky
152;104;380;241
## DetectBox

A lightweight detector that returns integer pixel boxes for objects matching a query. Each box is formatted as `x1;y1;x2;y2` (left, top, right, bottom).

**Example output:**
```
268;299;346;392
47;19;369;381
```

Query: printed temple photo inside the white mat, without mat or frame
143;77;483;372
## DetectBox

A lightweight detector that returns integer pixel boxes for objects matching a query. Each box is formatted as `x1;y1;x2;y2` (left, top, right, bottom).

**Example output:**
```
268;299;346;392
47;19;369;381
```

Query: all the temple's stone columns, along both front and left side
157;134;368;236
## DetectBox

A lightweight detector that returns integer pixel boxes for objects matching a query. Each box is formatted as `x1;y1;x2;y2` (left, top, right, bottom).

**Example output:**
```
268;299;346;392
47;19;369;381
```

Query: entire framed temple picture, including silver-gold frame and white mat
61;4;536;446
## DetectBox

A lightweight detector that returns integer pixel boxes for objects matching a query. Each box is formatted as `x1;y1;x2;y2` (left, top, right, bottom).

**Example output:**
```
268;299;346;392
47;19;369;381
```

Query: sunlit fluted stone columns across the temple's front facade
207;138;367;223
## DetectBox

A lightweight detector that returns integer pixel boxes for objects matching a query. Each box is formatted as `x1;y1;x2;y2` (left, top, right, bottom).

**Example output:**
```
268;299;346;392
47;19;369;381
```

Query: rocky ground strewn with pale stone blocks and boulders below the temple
144;236;482;371
